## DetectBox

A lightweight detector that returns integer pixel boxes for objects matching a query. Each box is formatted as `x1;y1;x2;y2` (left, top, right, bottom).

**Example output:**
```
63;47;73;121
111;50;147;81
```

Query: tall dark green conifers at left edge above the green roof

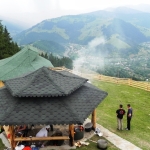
0;22;20;59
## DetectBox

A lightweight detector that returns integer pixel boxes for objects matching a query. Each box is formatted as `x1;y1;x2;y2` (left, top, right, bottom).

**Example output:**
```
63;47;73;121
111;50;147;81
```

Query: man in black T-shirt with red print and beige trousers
116;104;126;130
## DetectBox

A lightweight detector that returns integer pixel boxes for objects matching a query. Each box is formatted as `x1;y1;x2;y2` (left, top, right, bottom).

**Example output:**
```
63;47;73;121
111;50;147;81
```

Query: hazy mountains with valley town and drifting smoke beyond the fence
10;7;150;80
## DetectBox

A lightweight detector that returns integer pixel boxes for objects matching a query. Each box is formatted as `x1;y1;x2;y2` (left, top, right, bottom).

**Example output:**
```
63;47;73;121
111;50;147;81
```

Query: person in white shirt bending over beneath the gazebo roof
36;125;50;147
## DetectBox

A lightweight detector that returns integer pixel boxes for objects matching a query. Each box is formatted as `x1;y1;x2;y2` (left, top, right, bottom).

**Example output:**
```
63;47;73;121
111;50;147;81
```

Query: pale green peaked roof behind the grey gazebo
0;46;53;80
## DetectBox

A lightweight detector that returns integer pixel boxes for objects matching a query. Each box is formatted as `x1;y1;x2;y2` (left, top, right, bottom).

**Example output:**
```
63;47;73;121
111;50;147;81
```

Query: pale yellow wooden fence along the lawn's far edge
0;67;150;91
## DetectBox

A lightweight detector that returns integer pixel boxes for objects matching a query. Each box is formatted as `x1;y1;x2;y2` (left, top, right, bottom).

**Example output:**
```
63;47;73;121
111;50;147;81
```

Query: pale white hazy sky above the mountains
0;0;150;27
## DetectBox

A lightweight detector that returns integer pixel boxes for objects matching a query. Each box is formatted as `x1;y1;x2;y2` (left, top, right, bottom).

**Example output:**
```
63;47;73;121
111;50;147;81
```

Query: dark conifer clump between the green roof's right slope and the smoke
41;53;73;69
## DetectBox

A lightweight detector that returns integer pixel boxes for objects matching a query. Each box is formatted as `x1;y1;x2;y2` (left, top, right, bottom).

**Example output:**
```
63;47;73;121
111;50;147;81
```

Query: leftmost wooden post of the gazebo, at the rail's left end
9;126;16;150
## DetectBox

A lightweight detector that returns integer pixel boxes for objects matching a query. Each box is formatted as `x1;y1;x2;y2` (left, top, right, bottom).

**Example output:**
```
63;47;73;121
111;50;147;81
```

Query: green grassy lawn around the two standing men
93;81;150;150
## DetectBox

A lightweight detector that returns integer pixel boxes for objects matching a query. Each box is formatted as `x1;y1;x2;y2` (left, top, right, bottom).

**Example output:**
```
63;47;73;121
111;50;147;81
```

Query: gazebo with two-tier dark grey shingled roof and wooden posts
0;67;107;150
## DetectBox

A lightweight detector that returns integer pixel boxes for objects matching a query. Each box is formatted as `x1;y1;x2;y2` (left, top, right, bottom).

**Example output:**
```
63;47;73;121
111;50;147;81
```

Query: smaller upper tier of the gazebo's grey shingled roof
4;67;88;97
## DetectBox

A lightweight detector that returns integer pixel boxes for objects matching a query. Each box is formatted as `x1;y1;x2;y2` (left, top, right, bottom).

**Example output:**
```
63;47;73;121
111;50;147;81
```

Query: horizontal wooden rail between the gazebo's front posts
14;136;70;141
